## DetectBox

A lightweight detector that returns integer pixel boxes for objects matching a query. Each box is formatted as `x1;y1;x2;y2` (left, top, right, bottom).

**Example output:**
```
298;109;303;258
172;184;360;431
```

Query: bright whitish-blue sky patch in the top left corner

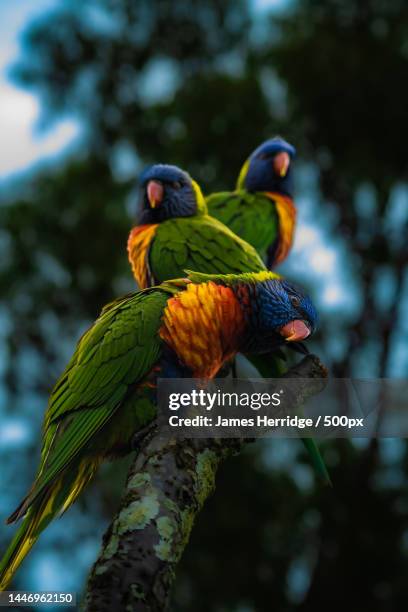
0;0;79;180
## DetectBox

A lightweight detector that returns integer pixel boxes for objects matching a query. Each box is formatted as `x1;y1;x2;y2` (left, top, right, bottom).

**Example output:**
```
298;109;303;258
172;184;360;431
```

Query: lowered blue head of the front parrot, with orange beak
241;277;317;353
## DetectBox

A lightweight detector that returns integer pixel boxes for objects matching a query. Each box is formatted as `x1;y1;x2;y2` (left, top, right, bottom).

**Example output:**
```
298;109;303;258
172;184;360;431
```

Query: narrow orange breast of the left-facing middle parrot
127;224;158;289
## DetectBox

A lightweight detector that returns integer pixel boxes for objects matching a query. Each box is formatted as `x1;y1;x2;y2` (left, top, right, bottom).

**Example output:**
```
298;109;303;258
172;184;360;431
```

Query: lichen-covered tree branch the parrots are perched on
83;355;327;612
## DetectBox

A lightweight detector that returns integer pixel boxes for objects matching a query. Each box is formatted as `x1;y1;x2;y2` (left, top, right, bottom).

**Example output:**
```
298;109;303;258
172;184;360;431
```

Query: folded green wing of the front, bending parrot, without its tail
21;288;169;512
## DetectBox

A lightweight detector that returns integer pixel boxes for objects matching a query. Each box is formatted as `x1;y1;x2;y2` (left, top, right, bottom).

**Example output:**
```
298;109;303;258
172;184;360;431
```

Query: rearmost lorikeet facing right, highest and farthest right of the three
206;137;296;269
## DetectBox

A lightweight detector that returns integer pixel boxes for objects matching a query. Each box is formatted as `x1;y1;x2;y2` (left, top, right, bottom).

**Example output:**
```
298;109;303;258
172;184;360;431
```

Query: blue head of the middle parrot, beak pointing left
138;164;205;224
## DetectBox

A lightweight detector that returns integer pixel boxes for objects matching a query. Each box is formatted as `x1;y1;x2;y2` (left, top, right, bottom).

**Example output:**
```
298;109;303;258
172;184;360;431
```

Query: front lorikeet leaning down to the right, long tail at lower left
0;272;316;590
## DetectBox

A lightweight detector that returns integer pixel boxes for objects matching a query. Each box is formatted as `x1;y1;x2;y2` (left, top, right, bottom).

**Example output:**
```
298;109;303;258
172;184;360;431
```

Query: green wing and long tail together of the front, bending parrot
0;289;169;589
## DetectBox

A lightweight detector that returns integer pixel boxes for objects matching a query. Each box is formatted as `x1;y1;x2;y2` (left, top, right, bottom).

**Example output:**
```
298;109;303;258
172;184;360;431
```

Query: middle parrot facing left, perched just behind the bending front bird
127;164;331;483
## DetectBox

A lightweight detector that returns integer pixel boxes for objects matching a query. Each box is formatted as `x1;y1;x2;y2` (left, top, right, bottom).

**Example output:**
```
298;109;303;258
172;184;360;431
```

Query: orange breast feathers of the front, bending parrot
160;282;245;379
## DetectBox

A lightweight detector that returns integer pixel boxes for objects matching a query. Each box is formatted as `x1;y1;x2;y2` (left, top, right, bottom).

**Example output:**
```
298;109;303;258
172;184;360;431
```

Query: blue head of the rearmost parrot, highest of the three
238;137;296;198
